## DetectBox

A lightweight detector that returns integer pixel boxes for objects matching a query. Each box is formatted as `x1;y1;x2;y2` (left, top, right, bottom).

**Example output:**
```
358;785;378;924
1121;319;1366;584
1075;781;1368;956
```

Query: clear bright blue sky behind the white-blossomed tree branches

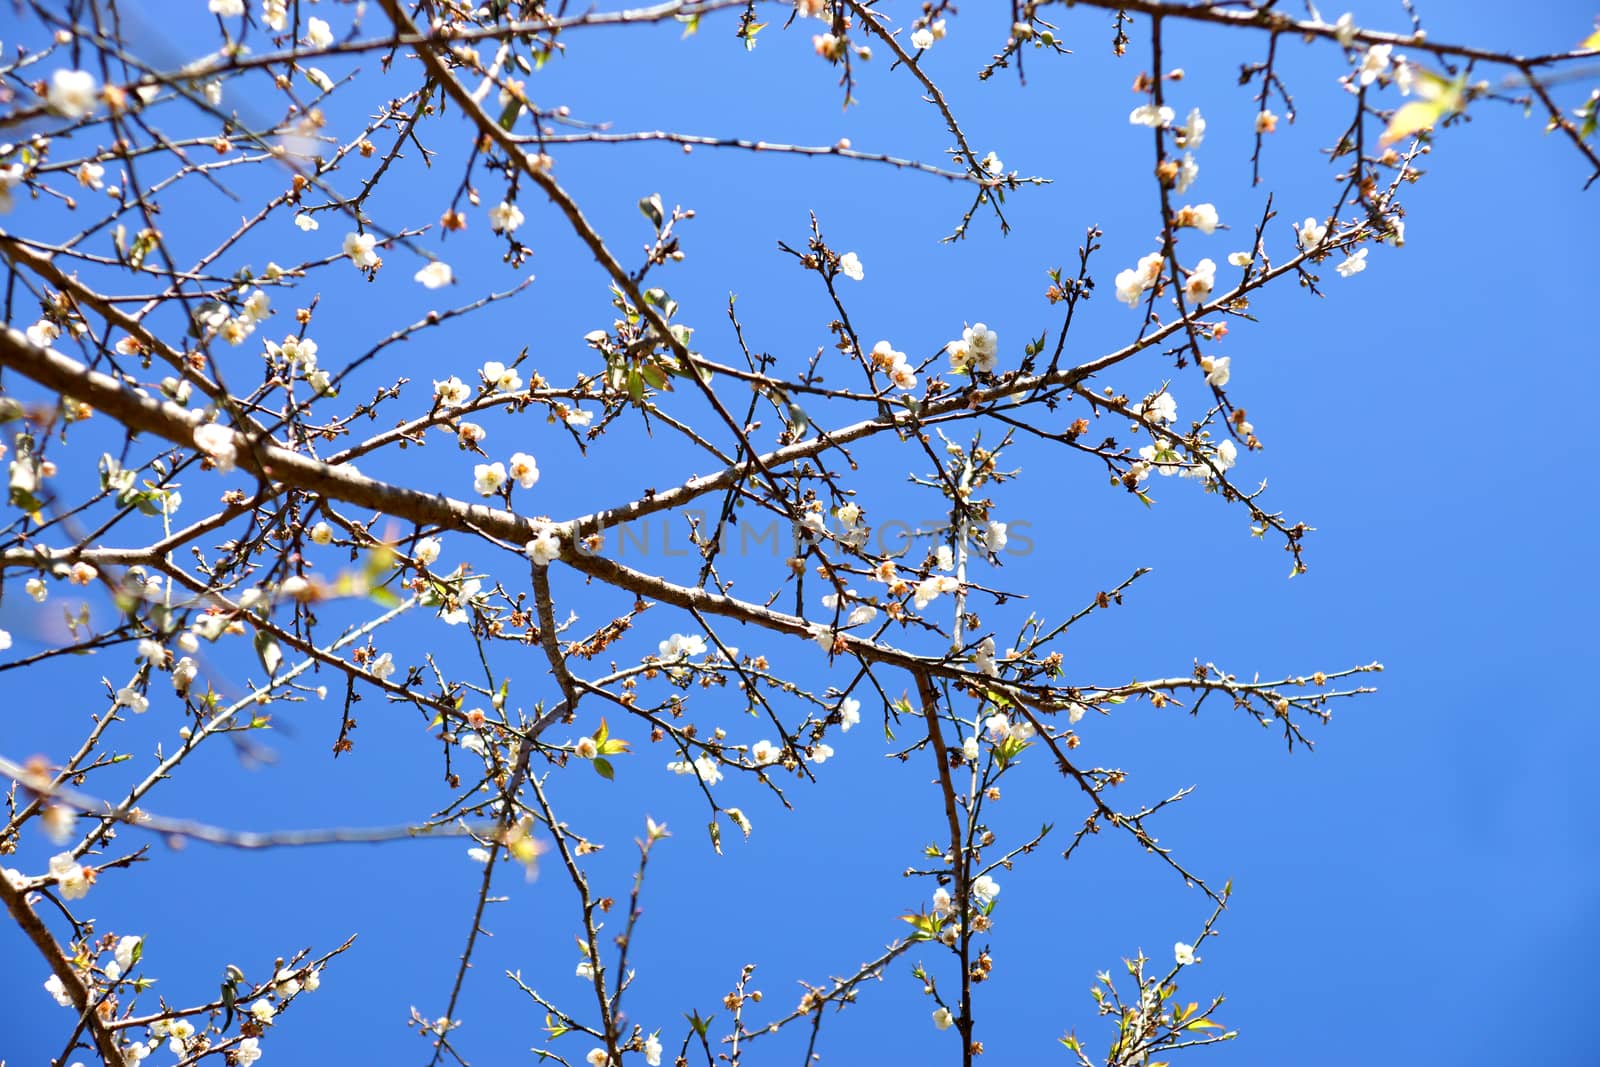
0;2;1600;1065
